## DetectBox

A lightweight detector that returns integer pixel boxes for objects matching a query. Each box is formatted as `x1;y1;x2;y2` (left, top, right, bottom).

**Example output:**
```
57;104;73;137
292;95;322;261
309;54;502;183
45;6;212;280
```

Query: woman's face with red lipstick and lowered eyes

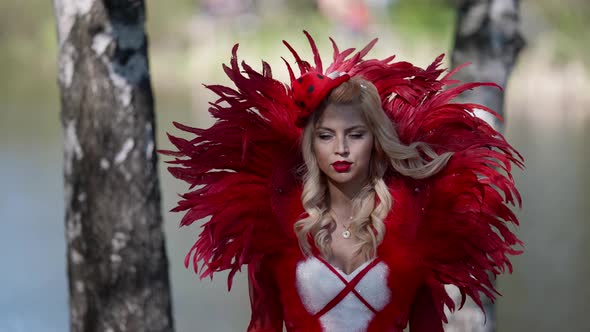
313;105;373;191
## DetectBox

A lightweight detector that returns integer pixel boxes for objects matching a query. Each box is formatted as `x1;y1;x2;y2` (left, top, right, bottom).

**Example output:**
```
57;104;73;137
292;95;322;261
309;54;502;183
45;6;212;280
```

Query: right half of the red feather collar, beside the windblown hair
360;55;523;318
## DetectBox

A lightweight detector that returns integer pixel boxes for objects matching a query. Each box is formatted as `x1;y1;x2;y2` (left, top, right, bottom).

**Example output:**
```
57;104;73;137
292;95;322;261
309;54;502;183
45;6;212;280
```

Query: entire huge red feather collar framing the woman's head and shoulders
160;32;522;313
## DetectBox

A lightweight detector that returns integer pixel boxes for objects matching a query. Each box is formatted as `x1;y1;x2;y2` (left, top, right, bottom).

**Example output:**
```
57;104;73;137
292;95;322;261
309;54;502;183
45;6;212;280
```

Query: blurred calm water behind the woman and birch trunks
0;70;590;332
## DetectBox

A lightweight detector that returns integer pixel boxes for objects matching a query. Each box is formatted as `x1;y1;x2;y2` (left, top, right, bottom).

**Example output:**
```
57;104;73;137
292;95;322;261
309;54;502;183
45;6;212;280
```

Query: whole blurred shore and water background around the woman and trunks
0;0;590;332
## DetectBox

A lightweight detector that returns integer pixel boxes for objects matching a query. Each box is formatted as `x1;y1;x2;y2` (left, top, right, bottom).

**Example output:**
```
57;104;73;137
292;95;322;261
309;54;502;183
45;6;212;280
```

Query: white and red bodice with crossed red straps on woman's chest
275;245;426;331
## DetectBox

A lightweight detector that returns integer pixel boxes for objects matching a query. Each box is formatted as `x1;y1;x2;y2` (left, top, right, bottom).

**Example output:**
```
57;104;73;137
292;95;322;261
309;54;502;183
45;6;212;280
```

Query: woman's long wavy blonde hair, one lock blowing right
294;77;452;260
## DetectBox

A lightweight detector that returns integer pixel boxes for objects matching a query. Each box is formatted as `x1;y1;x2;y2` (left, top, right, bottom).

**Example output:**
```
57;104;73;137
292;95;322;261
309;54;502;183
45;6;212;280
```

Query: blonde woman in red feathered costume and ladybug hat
164;33;521;332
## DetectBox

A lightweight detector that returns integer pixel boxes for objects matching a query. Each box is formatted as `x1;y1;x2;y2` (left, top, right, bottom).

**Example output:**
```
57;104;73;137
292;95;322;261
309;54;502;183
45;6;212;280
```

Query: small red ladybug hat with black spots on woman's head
291;72;350;128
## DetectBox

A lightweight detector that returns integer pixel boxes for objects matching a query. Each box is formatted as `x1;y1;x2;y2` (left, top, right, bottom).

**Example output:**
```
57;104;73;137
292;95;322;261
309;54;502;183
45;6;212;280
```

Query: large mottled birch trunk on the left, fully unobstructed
54;0;173;331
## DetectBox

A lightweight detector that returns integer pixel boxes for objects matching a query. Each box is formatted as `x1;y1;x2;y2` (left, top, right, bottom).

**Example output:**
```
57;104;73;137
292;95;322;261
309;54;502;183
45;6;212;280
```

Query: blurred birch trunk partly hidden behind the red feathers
445;0;524;332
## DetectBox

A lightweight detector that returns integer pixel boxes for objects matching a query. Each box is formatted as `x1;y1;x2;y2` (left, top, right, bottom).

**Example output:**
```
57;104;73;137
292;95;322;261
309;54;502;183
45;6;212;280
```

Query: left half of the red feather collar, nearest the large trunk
159;40;302;288
